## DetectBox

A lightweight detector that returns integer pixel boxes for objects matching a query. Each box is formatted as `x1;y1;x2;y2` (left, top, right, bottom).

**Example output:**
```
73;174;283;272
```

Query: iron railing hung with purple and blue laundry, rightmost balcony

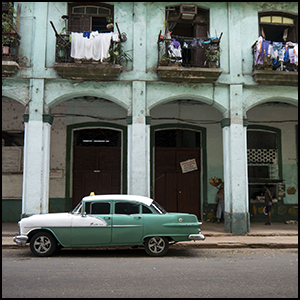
252;41;298;72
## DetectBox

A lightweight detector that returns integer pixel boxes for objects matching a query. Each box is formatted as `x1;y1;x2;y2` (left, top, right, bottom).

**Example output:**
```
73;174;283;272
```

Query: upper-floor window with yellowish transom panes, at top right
259;12;298;42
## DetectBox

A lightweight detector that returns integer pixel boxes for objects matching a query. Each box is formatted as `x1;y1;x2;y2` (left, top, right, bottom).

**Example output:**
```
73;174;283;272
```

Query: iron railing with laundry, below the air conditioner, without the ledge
157;33;222;68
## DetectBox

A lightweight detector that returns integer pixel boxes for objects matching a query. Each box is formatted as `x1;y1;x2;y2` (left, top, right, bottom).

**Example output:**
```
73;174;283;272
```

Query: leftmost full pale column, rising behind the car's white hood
22;79;53;217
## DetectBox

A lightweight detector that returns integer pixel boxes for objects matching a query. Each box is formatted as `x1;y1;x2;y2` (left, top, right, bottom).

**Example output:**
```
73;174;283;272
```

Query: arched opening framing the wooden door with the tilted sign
150;95;223;220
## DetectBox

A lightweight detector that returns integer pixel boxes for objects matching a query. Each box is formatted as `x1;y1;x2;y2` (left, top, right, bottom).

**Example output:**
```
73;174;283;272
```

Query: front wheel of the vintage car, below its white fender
30;232;57;256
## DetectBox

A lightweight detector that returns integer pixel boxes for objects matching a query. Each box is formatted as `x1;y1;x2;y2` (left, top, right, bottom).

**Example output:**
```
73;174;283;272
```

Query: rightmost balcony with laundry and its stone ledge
252;42;298;86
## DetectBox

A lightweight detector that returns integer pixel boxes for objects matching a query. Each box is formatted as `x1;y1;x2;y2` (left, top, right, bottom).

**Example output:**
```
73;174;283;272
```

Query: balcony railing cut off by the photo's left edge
2;32;21;61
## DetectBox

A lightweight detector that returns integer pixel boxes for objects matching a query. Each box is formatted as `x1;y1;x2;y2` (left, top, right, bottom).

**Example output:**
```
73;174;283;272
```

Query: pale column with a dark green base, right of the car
221;85;250;235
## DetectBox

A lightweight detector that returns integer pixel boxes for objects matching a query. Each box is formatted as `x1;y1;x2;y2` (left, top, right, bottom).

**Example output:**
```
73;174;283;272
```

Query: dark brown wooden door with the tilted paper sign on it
154;147;201;219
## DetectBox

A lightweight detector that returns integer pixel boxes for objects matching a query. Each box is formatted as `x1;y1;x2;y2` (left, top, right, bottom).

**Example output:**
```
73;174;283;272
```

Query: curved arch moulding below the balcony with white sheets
47;90;129;110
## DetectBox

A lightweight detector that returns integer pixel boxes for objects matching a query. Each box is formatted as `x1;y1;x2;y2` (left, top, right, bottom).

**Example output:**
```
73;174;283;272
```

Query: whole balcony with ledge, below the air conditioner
157;34;222;83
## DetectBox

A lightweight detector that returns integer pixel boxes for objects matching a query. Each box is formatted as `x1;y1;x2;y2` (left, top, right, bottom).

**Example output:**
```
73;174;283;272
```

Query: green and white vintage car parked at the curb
13;195;205;256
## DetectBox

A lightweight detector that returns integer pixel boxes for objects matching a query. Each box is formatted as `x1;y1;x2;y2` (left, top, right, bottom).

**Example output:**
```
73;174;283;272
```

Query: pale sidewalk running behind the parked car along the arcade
2;223;298;249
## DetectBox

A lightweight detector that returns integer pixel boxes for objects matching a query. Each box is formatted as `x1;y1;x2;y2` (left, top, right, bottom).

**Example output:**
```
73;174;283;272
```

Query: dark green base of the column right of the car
225;212;250;235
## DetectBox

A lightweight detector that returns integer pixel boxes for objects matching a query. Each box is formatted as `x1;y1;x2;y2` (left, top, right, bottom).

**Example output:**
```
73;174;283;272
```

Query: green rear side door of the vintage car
112;201;143;245
